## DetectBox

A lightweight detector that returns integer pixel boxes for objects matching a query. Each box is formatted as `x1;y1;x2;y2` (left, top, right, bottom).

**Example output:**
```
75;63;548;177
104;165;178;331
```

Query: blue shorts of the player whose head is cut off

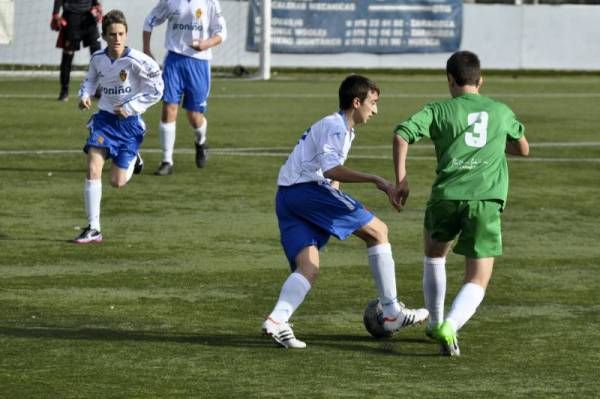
163;51;210;113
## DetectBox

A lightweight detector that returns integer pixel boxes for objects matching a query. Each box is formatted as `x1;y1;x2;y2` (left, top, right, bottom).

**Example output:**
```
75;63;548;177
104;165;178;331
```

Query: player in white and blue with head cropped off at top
143;0;227;176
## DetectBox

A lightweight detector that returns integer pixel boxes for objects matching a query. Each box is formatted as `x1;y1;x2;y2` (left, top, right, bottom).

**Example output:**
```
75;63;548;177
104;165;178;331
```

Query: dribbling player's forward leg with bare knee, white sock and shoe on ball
354;216;428;331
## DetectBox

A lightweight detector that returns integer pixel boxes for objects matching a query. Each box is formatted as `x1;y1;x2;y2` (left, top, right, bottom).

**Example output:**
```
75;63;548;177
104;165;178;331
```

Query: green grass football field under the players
0;72;600;398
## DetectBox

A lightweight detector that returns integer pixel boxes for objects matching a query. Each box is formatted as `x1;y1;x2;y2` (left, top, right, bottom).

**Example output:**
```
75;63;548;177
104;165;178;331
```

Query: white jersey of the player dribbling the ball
277;112;355;186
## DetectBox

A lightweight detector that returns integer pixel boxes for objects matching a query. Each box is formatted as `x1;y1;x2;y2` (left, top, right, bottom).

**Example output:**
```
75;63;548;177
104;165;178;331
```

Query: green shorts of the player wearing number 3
425;199;502;258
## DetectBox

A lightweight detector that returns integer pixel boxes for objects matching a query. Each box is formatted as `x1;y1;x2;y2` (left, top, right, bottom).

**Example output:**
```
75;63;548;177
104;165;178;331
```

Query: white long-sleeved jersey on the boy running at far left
79;47;164;115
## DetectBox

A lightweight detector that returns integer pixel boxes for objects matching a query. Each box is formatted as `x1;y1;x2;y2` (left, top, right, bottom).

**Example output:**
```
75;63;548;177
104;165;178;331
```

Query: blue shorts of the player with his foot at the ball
275;183;374;270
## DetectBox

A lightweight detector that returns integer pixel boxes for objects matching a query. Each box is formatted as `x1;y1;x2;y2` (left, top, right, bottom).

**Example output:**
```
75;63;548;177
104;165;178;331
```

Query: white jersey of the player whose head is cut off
144;0;227;60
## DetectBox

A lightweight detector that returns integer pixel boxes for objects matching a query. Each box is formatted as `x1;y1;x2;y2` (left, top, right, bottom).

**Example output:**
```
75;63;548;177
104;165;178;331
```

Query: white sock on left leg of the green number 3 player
423;256;446;326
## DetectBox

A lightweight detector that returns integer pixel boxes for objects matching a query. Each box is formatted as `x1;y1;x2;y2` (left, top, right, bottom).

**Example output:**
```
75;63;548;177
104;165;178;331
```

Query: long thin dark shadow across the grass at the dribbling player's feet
0;327;437;356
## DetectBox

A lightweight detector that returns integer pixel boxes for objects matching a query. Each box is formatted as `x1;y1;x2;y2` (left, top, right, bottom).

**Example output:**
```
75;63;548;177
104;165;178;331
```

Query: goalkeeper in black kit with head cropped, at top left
50;0;102;101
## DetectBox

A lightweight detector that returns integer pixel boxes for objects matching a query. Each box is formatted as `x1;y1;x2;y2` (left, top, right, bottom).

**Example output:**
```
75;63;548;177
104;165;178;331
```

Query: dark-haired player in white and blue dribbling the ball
262;75;428;348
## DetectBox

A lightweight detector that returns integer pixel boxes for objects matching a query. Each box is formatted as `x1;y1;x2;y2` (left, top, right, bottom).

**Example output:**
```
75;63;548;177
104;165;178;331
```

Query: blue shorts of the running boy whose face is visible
83;111;146;169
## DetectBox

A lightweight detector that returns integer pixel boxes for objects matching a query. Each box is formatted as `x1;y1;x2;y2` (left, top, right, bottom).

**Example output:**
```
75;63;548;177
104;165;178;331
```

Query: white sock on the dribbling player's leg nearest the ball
367;243;400;317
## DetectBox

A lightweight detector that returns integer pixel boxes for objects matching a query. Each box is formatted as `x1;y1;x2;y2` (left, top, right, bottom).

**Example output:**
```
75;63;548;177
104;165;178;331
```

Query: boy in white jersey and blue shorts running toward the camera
74;10;164;244
